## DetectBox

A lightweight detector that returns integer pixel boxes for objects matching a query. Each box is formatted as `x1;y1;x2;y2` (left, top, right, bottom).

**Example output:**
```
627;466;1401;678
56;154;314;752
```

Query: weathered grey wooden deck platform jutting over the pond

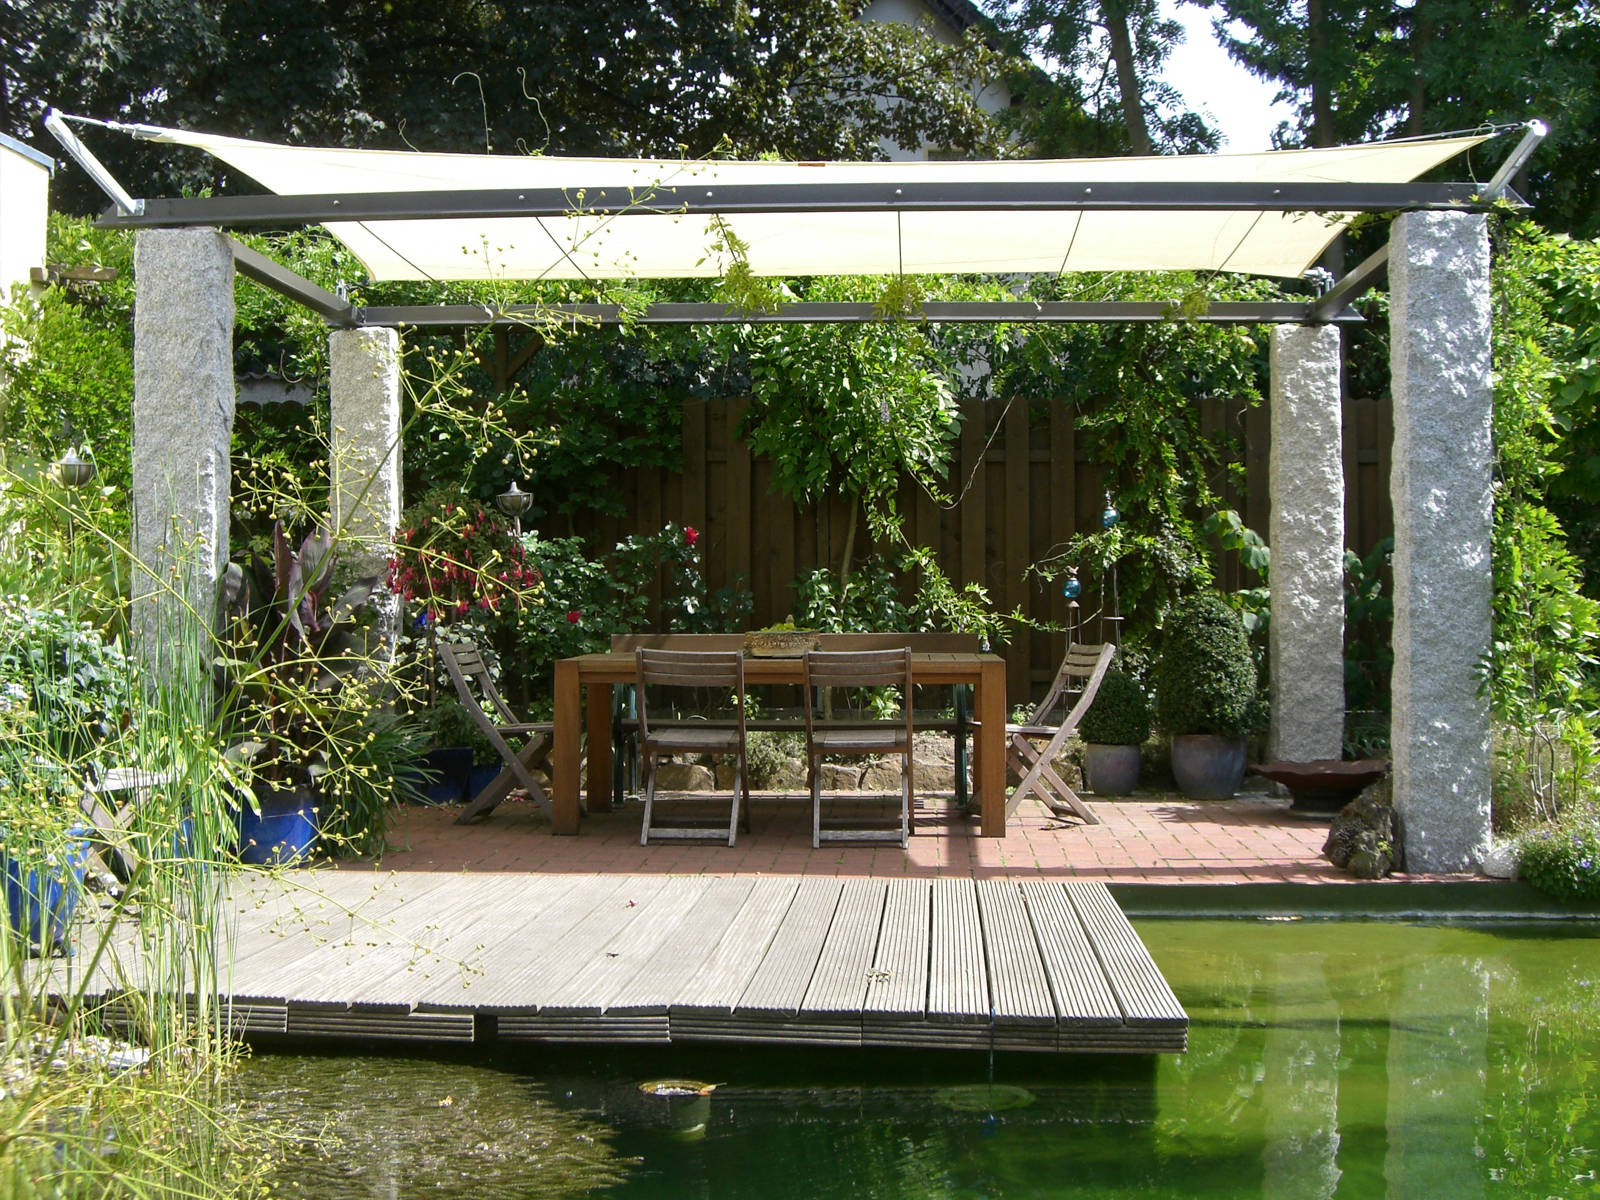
72;870;1189;1053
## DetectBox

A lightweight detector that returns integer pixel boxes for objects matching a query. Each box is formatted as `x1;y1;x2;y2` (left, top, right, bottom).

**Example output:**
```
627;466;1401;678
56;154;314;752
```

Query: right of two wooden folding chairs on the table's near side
803;646;914;850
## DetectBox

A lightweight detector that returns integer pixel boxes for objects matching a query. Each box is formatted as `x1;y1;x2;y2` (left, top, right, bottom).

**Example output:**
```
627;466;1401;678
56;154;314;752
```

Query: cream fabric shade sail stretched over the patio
144;130;1485;280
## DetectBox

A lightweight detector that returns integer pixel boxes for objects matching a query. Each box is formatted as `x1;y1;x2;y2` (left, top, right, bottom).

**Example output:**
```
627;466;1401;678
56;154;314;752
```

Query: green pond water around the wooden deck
240;920;1600;1200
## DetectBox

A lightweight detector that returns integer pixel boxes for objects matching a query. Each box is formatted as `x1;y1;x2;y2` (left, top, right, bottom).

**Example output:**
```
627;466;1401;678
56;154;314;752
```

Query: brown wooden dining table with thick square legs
550;648;1006;837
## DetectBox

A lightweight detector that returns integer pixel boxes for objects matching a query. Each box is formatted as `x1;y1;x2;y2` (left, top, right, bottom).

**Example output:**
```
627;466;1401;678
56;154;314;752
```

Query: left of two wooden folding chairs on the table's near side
634;648;750;846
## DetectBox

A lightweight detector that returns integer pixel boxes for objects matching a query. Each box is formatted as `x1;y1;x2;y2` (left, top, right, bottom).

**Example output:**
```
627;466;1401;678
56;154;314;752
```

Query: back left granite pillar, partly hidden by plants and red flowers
328;330;402;659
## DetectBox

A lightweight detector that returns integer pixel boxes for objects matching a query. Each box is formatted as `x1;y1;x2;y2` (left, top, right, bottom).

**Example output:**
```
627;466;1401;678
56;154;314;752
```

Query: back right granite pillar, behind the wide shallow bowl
1267;325;1344;762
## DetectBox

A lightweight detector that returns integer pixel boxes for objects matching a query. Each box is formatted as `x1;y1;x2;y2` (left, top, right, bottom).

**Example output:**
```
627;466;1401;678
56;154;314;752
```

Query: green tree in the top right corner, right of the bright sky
1186;0;1600;235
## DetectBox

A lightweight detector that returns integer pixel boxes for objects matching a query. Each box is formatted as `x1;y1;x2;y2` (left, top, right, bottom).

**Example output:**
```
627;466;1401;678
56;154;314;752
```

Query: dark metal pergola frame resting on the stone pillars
56;112;1547;330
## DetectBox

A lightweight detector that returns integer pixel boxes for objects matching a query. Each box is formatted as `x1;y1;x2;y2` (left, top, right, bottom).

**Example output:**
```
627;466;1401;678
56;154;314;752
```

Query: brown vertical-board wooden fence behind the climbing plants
578;390;1394;704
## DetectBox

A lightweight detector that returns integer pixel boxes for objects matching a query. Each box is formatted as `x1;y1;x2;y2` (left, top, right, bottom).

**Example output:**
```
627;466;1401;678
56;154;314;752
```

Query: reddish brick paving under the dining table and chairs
346;795;1427;883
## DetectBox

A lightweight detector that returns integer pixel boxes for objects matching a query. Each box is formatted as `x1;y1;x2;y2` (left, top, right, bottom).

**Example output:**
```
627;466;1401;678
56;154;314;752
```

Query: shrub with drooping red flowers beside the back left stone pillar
389;493;541;624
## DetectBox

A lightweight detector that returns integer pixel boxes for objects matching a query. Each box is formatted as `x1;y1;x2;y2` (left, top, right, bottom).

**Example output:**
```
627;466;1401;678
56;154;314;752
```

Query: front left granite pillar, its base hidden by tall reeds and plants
133;229;235;678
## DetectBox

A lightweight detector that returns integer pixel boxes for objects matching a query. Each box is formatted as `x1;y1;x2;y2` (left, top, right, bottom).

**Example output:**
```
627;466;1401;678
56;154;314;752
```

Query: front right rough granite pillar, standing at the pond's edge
1389;213;1493;870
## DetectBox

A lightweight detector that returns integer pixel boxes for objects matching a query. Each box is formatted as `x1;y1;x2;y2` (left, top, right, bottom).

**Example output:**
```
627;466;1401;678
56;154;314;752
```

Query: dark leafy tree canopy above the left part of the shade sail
3;0;1005;208
